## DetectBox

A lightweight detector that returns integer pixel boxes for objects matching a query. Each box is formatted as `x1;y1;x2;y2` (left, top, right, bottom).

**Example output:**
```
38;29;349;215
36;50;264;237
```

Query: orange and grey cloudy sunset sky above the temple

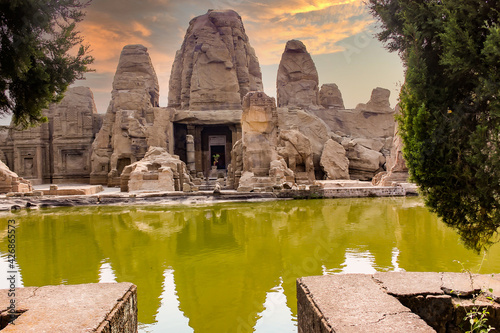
79;0;404;113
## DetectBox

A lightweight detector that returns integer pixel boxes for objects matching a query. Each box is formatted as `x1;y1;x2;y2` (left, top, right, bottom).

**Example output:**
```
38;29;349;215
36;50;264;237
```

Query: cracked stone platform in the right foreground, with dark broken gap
297;272;500;333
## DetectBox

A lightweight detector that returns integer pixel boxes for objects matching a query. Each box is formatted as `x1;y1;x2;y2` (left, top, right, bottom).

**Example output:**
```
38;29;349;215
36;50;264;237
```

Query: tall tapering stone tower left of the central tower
90;45;160;186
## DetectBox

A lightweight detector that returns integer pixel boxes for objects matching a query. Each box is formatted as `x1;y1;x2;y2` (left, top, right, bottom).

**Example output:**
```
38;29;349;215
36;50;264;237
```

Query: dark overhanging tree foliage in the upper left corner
0;0;93;127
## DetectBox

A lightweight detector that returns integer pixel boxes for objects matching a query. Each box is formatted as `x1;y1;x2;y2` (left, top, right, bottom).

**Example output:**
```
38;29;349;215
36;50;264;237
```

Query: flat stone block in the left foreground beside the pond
0;282;137;333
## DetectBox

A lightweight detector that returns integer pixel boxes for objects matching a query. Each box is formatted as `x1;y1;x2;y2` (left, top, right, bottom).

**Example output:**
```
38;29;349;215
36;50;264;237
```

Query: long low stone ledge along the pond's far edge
0;181;417;211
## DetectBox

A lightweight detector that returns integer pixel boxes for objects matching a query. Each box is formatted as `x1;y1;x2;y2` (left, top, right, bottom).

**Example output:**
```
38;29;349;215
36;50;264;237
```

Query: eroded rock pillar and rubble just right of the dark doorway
229;92;315;191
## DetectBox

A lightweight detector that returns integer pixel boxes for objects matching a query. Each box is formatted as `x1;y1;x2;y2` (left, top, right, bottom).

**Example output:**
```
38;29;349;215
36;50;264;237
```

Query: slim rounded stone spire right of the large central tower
276;40;319;108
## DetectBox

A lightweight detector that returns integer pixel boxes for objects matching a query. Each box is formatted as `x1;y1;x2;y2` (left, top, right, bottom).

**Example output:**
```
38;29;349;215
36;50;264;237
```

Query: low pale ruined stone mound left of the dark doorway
121;147;191;192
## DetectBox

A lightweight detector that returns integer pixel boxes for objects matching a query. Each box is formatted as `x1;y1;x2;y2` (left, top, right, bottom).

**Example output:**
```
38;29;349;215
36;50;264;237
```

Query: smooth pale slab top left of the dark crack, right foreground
298;274;434;333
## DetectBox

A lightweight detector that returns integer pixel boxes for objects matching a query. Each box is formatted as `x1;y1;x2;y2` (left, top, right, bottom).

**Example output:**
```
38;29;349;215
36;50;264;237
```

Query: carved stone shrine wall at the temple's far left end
2;87;102;185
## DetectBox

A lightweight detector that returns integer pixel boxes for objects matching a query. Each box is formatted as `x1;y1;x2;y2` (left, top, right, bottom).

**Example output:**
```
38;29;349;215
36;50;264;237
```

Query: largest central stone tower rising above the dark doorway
168;10;263;110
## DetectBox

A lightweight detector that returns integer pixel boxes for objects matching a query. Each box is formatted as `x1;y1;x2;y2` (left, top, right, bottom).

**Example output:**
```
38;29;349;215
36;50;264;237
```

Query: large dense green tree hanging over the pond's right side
369;0;500;251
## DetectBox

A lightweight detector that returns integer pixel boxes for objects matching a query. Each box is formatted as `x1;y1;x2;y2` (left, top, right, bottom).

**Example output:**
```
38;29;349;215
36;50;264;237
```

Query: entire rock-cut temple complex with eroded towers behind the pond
0;10;405;190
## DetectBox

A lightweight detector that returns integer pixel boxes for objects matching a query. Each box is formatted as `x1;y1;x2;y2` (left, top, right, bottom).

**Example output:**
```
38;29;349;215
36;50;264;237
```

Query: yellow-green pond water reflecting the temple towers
0;198;500;333
